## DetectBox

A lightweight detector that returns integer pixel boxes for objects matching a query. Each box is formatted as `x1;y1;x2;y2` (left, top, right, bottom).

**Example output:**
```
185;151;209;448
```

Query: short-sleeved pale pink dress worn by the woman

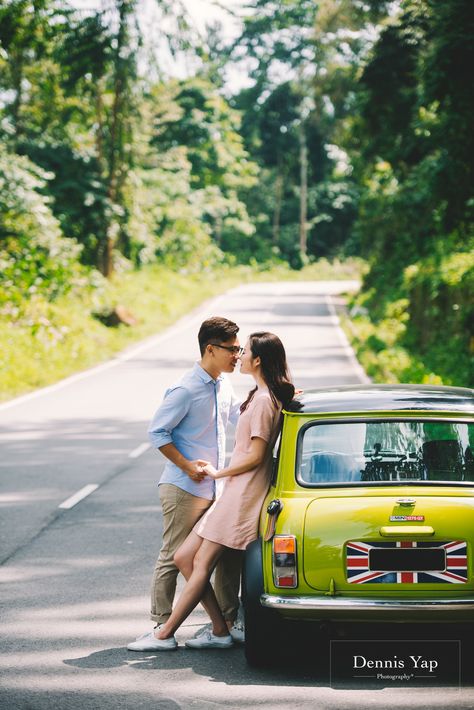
193;388;281;550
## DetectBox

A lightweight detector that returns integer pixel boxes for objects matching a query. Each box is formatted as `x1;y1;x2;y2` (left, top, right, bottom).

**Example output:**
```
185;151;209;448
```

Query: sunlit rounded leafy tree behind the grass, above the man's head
150;78;257;266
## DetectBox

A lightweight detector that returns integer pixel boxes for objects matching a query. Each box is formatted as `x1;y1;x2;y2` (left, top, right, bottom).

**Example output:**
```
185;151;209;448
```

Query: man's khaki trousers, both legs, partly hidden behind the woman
150;483;242;624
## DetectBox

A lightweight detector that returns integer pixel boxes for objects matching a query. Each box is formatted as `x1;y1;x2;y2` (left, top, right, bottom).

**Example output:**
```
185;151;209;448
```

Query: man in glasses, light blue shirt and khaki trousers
127;317;243;651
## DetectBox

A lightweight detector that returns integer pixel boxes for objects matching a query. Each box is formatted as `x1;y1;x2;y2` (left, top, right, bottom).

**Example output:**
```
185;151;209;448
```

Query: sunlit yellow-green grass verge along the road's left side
0;259;364;401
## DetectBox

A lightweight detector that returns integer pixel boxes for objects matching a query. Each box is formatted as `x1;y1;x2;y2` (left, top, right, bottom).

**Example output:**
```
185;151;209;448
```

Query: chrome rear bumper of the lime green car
260;594;474;620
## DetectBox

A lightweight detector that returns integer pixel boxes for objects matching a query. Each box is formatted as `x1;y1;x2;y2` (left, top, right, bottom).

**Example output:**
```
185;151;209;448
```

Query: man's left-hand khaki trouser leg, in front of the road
150;483;212;624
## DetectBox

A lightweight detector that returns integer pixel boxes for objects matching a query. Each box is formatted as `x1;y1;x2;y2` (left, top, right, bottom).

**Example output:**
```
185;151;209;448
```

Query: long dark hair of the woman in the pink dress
240;331;295;412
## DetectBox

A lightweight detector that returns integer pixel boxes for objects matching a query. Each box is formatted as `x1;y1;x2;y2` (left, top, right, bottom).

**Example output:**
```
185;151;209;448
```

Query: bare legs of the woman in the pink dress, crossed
155;532;228;638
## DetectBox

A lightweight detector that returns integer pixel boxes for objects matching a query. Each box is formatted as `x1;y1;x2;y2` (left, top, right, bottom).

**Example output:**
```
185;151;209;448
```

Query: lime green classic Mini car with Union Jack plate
243;385;474;665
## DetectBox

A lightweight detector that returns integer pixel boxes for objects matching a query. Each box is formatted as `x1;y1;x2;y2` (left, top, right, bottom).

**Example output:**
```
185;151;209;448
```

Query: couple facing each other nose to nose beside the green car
127;318;294;651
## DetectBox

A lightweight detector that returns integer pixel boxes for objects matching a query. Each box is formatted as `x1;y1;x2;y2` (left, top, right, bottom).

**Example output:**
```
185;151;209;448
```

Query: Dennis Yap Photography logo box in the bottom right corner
330;640;461;687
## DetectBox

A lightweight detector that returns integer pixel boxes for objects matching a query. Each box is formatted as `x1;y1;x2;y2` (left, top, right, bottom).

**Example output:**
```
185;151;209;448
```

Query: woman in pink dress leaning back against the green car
133;332;294;651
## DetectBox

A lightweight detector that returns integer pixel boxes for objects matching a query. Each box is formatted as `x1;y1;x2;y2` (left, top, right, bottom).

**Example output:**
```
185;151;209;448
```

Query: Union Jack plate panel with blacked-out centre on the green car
346;540;467;584
